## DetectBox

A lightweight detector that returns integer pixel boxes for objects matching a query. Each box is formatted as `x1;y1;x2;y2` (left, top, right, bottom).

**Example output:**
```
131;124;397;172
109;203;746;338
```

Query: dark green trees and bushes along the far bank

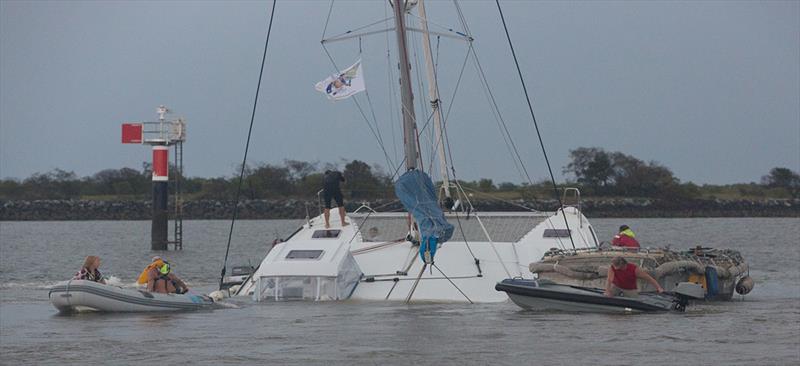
0;147;800;200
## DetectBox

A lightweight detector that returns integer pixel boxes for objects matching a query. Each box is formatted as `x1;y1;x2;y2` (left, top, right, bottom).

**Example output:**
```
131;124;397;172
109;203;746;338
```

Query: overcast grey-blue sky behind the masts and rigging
0;0;800;184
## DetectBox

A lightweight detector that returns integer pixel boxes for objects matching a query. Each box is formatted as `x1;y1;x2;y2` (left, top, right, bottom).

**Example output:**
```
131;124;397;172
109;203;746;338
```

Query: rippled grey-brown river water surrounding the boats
0;218;800;365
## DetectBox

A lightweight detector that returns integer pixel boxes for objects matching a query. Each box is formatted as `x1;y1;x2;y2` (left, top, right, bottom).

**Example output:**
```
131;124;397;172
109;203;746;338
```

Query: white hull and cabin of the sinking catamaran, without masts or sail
236;207;596;303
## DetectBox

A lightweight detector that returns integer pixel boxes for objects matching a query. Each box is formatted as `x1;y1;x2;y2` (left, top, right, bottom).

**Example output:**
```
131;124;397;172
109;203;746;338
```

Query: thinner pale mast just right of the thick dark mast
417;0;450;198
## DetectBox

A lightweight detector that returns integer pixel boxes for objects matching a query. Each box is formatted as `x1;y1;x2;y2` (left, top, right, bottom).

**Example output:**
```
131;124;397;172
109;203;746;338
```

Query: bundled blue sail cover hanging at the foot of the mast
394;169;453;263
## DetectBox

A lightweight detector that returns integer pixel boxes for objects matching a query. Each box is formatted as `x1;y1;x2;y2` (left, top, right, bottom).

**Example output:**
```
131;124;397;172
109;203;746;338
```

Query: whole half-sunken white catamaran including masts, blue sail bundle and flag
223;0;597;302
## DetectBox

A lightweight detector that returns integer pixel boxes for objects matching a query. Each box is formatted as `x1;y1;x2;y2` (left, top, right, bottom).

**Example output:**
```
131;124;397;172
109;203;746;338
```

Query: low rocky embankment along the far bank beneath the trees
0;198;800;221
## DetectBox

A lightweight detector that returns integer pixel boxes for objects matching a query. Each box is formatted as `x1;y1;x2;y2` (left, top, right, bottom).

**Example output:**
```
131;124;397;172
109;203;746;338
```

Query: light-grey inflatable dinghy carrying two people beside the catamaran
50;280;216;313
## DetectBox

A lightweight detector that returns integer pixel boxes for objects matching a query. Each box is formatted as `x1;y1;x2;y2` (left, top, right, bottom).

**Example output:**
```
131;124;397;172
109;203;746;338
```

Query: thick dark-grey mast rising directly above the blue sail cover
394;0;418;170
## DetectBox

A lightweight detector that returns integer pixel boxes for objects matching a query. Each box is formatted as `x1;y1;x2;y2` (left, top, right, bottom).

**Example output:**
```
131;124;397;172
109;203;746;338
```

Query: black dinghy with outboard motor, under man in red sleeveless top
495;279;677;314
